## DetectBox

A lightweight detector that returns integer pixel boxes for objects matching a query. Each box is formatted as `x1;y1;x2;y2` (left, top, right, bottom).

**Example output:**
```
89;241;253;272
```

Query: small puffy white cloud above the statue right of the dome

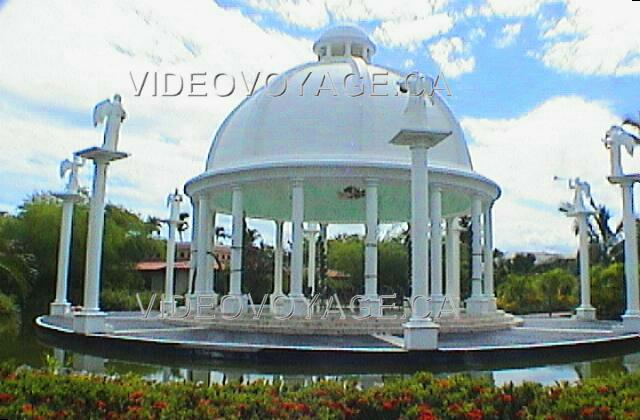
428;37;476;79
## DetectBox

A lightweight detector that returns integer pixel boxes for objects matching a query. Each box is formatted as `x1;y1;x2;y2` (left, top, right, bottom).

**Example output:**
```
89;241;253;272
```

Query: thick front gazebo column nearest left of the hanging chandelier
288;179;307;316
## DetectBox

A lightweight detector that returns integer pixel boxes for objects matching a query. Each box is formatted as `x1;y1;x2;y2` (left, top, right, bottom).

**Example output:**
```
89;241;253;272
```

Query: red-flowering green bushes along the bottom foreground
0;362;640;420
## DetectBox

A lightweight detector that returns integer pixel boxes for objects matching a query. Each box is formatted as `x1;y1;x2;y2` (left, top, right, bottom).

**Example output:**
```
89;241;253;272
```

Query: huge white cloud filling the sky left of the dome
0;0;314;220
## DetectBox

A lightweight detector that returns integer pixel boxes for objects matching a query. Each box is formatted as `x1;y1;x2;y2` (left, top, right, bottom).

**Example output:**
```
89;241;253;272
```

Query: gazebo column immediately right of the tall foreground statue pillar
429;187;444;317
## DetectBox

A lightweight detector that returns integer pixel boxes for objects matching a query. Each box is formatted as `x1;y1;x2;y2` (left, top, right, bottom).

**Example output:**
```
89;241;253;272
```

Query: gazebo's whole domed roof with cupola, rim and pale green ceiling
186;26;500;223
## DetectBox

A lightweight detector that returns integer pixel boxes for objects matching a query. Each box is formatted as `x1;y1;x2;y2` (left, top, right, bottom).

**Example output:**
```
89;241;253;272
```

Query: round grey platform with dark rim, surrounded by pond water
36;312;640;371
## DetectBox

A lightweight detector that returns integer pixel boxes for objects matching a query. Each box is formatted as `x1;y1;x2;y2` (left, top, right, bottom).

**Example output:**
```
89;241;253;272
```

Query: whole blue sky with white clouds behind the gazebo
0;0;640;252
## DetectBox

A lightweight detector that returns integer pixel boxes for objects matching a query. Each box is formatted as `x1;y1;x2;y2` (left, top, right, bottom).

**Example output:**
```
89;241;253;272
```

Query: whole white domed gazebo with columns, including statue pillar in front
185;26;500;349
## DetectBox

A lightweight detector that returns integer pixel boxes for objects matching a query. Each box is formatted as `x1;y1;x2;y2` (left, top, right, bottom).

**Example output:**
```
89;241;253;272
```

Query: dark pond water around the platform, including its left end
7;325;640;387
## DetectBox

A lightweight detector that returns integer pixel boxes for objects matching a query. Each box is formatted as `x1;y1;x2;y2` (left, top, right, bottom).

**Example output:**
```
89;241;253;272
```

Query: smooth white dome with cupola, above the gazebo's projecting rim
207;27;472;173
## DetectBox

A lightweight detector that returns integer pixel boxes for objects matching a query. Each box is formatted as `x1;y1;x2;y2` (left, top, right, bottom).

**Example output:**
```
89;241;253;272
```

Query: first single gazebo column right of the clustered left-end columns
222;185;245;314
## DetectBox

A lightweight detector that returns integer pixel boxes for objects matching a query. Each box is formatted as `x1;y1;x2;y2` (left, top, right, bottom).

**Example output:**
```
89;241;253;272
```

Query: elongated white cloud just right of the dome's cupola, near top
373;13;454;51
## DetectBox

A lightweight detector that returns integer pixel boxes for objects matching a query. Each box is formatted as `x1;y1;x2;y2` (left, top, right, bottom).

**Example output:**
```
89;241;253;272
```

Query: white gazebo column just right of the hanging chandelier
360;179;382;317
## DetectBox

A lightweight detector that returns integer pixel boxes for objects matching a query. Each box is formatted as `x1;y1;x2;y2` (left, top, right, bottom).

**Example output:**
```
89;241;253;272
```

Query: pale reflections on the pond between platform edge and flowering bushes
48;348;640;388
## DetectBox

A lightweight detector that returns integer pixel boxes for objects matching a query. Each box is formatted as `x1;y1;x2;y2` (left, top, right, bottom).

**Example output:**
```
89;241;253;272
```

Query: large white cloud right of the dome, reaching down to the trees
462;96;640;252
